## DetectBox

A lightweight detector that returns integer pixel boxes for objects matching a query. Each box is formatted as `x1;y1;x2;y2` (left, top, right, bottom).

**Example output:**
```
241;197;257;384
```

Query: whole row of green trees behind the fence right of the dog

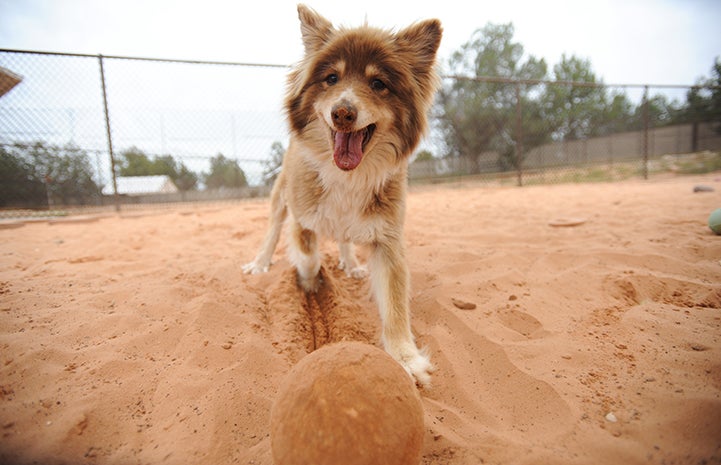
436;23;721;170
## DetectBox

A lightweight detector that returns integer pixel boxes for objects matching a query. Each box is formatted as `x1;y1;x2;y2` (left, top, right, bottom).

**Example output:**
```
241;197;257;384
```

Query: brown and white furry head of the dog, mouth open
285;5;442;171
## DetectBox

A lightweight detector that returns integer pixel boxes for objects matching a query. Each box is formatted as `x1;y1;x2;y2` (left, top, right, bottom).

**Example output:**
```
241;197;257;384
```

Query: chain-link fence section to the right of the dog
410;76;721;186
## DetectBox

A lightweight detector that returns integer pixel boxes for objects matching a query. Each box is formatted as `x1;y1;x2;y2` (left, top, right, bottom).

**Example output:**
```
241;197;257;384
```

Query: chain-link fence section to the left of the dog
0;50;288;216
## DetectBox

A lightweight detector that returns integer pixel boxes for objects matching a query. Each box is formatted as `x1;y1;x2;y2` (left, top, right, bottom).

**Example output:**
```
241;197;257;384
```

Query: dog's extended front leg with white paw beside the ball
371;239;433;386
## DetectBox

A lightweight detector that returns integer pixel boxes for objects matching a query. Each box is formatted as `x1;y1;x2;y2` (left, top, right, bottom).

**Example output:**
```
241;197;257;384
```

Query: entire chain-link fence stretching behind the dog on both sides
0;50;721;217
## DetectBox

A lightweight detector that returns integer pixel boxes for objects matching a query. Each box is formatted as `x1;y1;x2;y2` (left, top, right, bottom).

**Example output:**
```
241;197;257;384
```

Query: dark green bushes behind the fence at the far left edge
0;142;100;206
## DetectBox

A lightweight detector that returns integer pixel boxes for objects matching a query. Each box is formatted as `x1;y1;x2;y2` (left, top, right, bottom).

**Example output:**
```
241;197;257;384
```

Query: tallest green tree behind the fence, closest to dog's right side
438;23;547;172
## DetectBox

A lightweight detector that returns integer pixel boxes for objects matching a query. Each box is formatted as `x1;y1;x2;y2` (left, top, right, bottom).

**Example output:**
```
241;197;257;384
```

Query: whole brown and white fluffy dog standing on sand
243;5;443;386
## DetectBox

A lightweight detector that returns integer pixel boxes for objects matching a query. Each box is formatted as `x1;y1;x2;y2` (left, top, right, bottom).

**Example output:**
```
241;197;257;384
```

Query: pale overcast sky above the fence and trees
0;0;721;84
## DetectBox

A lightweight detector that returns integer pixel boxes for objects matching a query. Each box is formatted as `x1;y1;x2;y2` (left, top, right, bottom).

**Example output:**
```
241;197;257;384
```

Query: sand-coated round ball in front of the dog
270;342;424;465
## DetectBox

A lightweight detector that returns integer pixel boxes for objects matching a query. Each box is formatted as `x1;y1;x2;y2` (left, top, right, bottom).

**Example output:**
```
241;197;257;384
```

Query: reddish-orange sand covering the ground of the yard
0;174;721;465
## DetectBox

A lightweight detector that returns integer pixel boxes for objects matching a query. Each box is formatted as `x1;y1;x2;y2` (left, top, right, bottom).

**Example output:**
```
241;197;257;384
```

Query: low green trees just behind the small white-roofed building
119;147;198;191
